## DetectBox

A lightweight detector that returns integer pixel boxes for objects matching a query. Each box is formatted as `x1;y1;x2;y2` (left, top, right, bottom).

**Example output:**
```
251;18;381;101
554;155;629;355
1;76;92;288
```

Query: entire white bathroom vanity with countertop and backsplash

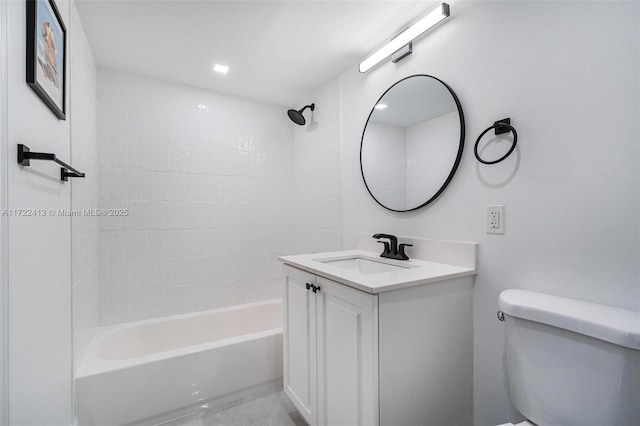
280;235;477;426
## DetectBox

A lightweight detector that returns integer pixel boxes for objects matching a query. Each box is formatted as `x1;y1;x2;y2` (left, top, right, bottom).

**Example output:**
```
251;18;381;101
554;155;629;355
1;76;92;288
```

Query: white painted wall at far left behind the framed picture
7;0;73;425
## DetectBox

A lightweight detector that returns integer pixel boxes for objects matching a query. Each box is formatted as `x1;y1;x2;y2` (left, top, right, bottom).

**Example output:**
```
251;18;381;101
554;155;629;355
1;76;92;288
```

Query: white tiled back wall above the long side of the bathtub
98;70;294;325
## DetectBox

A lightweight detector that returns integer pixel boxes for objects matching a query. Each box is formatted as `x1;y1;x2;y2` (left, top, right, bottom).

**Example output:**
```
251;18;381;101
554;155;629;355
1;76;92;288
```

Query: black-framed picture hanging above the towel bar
26;0;67;120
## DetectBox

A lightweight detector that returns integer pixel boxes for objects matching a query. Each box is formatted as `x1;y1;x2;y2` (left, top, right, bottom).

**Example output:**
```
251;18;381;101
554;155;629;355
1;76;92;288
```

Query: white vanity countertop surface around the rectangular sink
278;250;476;294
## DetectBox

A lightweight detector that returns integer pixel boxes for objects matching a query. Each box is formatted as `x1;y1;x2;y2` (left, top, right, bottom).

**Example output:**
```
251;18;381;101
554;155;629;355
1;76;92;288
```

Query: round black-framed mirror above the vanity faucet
360;75;464;212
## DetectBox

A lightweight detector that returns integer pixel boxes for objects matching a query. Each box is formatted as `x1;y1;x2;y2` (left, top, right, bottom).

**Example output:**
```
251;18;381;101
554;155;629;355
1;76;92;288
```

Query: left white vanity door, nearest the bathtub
283;266;317;426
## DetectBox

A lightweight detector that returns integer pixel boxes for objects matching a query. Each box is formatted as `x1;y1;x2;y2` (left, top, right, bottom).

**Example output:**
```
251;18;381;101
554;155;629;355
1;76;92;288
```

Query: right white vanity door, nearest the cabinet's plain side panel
316;277;378;426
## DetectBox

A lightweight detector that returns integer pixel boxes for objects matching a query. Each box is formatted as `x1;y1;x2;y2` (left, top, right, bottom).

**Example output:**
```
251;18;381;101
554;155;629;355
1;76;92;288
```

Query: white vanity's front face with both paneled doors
283;266;378;425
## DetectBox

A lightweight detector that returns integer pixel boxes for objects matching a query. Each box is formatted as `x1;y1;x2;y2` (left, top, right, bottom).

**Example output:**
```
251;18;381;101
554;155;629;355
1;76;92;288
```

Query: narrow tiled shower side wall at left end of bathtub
69;3;99;371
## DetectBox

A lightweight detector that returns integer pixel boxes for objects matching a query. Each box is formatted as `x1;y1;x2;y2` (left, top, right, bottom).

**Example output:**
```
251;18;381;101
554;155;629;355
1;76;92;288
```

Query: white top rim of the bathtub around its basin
75;298;283;379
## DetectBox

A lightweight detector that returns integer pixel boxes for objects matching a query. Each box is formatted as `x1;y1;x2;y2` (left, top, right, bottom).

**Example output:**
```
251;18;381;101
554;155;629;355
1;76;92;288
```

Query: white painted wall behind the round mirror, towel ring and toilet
332;2;640;425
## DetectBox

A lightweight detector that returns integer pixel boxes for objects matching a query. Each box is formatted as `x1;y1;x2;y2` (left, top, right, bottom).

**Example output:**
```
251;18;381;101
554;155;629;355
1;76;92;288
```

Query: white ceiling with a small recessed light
76;0;433;107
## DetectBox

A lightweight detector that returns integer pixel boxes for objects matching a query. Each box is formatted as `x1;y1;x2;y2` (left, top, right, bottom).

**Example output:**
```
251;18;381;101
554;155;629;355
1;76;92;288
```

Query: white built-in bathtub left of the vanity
75;299;282;426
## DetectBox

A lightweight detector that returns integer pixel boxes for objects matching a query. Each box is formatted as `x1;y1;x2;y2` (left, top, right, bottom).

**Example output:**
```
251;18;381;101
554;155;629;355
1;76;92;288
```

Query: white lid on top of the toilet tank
498;289;640;350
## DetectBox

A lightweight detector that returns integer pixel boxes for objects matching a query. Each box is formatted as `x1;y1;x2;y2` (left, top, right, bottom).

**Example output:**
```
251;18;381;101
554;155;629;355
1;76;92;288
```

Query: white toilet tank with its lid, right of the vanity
498;290;640;426
